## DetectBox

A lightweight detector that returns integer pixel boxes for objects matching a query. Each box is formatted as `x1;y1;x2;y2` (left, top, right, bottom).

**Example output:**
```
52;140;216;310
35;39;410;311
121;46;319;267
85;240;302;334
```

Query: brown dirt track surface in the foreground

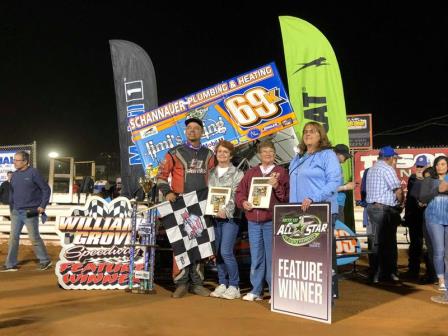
0;243;448;336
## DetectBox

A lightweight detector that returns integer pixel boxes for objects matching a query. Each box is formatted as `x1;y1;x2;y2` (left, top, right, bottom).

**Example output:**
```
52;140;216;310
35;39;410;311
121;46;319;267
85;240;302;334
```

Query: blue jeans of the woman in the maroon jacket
247;221;272;296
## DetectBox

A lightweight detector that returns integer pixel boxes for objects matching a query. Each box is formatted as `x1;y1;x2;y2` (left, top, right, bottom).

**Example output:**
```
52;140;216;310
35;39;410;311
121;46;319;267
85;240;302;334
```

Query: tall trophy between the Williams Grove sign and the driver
128;172;157;294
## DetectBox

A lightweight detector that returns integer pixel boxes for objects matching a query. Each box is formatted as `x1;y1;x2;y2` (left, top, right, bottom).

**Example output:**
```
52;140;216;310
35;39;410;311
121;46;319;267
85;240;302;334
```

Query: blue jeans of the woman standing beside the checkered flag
215;219;240;287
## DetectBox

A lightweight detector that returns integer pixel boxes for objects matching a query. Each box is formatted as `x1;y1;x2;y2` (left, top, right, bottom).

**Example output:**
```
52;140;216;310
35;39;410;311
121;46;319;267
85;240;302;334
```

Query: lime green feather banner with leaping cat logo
279;16;352;230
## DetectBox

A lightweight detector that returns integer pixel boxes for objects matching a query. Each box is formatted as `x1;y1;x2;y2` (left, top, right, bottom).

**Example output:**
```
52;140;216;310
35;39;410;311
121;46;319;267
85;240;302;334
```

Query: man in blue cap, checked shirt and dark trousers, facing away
366;146;403;283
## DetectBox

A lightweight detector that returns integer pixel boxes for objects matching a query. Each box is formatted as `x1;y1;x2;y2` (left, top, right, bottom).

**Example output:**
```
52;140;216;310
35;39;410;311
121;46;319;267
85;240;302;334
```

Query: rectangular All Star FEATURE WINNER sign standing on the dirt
271;203;332;323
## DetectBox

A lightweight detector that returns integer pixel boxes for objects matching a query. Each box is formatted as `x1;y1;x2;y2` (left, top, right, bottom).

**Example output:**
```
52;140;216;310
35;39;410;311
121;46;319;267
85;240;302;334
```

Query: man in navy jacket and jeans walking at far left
3;151;52;272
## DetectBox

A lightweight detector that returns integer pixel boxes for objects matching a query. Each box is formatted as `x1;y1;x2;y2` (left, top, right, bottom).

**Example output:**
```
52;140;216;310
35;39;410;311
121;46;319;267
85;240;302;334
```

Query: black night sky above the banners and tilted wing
0;1;448;169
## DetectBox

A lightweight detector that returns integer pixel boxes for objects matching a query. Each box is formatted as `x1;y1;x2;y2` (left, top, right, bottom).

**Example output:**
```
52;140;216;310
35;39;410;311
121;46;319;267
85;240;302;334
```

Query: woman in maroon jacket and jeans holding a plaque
235;141;289;301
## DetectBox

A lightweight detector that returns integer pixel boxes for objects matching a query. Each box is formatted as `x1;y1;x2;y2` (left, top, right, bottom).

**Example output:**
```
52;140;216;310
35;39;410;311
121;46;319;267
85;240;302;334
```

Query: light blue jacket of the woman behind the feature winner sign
289;149;342;214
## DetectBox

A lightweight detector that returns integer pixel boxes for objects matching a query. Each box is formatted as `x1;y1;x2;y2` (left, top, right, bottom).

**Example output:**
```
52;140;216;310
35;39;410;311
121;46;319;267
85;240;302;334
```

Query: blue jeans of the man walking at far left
5;210;50;268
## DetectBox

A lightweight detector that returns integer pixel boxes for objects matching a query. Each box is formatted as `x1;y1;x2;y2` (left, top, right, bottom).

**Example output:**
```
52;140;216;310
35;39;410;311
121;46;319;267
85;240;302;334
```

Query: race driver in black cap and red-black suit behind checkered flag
157;118;215;298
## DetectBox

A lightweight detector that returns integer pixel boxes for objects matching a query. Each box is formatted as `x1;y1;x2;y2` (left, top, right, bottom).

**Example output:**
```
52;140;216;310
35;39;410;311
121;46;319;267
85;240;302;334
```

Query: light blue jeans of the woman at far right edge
426;224;448;281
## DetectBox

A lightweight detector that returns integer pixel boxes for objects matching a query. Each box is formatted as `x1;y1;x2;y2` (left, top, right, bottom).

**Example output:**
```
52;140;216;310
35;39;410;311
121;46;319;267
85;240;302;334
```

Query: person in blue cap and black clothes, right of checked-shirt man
403;155;435;280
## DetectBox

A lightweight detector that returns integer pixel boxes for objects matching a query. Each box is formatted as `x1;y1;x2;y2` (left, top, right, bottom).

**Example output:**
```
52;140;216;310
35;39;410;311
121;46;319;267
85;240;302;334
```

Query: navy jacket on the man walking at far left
9;167;51;210
